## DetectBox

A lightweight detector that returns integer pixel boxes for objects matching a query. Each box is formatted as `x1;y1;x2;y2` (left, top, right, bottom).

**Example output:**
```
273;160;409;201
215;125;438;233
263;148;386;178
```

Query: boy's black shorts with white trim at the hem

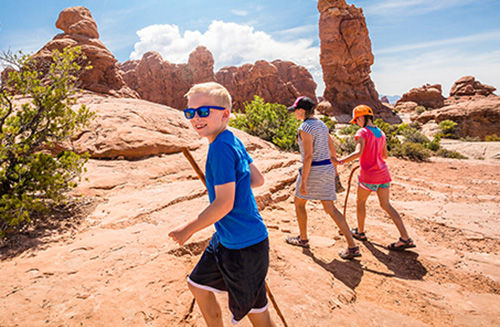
188;235;269;322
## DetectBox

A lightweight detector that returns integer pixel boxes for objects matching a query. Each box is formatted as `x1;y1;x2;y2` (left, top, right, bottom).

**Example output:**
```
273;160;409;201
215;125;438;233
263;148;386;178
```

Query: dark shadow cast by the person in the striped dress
303;249;363;290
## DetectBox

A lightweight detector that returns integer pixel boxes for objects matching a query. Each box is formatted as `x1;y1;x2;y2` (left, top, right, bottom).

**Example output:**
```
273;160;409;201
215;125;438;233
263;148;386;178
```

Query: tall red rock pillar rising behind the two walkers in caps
318;0;401;123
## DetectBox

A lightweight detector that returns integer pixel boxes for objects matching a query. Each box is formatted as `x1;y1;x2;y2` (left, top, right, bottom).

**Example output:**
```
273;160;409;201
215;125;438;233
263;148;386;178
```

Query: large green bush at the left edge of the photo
0;48;92;237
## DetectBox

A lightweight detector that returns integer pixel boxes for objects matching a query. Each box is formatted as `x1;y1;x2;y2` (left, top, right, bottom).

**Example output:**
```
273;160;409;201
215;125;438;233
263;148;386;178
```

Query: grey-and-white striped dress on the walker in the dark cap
295;118;337;201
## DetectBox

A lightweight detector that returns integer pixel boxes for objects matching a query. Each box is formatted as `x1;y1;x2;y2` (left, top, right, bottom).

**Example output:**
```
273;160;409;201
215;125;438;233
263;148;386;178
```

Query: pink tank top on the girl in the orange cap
355;127;391;184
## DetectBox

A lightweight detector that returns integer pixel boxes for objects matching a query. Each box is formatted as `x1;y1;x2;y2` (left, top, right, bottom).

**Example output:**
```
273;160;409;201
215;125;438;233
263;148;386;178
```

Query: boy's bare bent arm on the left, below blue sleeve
168;182;236;245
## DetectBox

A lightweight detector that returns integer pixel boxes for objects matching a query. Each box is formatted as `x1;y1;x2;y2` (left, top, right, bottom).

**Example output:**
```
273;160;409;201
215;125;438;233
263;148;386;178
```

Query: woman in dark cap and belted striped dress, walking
286;96;361;259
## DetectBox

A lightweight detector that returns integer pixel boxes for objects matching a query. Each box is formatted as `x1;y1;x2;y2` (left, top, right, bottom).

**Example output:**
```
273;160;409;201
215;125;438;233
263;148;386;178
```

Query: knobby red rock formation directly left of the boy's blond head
120;46;215;109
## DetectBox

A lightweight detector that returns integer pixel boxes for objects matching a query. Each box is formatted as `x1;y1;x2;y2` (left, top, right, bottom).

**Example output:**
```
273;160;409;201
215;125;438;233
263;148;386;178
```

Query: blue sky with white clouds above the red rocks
0;0;500;96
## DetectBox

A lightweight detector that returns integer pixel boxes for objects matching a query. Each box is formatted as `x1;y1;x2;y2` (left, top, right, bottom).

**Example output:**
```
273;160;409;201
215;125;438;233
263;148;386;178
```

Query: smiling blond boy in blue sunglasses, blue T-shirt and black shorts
169;82;275;327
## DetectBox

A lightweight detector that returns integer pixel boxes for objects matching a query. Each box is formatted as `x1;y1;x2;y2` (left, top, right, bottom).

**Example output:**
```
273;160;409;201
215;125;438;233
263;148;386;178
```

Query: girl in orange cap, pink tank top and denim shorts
339;105;415;251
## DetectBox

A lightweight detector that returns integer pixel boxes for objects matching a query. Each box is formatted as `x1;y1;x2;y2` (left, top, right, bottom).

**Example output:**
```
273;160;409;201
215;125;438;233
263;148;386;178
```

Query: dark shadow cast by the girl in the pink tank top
363;241;427;280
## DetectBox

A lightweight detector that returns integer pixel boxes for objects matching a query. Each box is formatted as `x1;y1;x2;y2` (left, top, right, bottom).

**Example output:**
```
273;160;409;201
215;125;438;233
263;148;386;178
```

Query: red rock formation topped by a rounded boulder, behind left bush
33;7;137;98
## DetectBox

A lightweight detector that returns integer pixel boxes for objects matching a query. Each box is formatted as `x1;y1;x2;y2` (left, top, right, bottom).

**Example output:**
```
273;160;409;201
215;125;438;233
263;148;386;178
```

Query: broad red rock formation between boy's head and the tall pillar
215;60;316;110
